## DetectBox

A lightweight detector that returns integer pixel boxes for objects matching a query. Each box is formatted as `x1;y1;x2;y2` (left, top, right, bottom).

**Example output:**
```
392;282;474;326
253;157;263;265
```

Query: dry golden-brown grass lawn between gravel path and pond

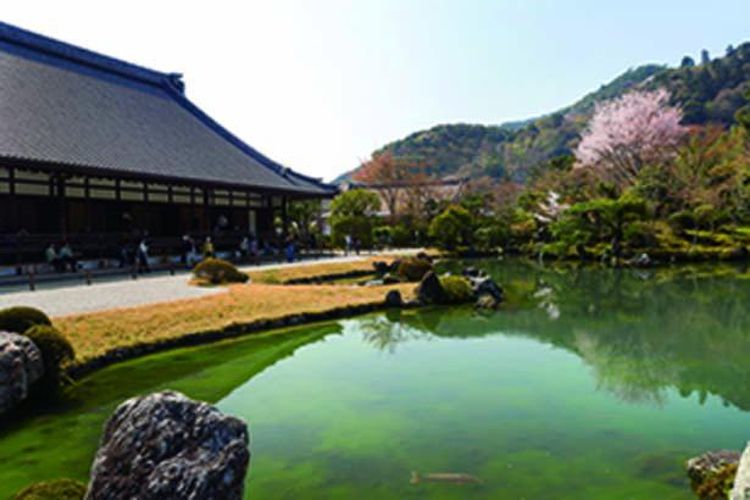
54;259;414;362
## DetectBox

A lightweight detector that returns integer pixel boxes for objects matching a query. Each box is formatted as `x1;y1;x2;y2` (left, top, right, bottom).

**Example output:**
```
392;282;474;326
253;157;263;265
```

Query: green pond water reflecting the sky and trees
0;262;750;499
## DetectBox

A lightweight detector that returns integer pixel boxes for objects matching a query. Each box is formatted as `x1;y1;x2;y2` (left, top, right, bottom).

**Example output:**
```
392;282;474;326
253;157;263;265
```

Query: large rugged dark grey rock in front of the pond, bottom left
86;391;250;500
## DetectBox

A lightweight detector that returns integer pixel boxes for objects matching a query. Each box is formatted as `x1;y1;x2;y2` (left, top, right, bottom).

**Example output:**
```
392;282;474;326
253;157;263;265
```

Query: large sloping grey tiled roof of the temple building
0;23;336;195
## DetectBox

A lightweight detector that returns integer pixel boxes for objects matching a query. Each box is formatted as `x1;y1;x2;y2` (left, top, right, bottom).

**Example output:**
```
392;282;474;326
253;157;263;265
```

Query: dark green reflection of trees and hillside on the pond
364;261;750;411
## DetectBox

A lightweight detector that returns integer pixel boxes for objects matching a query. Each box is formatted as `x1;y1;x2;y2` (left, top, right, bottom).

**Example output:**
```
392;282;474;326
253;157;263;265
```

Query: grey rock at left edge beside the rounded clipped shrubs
0;332;44;414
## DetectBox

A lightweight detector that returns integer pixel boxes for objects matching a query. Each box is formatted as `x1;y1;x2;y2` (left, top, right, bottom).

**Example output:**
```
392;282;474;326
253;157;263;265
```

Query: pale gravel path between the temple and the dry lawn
0;257;388;316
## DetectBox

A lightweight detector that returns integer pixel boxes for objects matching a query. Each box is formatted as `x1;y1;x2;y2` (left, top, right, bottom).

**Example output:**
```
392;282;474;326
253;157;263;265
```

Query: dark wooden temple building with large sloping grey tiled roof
0;23;336;264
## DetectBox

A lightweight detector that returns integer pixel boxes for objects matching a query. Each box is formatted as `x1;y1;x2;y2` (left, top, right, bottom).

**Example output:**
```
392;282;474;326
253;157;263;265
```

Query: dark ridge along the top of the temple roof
0;21;184;90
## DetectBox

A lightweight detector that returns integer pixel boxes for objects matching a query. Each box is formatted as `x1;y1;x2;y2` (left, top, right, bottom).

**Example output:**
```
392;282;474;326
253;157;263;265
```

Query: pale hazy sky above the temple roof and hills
1;0;750;179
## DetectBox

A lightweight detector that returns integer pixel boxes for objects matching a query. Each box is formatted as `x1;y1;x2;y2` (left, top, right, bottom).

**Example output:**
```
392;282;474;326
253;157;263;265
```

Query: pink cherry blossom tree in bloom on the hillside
575;89;687;186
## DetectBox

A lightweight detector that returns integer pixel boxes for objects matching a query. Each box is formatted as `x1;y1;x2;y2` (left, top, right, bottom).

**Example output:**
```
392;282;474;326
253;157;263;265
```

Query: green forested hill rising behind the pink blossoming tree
337;43;750;182
